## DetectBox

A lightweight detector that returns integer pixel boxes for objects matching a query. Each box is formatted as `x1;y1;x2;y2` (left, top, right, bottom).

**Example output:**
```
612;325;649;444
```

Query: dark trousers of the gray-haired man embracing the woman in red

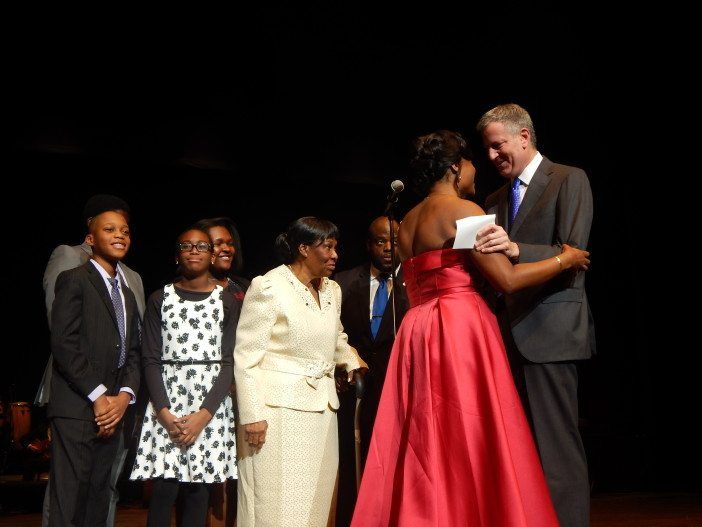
502;326;590;527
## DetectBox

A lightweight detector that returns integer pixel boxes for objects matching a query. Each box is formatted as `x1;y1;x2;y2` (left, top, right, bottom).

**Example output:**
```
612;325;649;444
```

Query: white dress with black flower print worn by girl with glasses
131;284;236;483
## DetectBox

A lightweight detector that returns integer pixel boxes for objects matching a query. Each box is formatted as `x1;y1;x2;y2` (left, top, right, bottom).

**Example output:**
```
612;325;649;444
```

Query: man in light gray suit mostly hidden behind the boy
34;194;145;527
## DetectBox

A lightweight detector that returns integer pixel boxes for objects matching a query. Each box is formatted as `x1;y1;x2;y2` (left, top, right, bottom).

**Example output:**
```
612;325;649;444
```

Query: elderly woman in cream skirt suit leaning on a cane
234;217;366;527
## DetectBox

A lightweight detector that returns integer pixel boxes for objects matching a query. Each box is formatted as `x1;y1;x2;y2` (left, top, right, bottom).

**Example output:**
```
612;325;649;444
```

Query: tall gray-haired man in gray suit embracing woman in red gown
476;104;595;527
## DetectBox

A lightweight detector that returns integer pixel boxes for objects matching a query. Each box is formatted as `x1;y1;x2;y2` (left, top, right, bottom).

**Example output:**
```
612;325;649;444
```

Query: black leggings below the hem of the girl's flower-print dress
146;478;210;527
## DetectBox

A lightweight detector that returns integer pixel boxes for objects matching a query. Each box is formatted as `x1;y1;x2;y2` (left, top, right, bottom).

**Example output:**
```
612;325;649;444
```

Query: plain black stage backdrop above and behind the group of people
5;3;702;500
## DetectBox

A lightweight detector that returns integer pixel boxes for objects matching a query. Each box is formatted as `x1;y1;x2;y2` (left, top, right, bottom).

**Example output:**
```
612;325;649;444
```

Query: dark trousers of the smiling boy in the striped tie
49;417;121;527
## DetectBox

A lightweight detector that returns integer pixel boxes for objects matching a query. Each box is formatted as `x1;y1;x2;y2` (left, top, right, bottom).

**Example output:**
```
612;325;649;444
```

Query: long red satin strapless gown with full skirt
351;249;558;527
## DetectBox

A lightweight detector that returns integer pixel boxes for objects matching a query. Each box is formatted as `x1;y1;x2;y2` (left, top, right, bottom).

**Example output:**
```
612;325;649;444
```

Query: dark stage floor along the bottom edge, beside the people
0;493;702;527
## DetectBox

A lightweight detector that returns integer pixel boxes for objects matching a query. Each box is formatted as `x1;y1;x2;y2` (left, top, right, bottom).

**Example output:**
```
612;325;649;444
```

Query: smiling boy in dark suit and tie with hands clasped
48;211;139;527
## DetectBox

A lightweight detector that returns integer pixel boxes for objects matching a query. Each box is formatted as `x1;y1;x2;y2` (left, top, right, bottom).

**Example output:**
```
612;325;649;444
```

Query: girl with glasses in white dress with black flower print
131;229;240;527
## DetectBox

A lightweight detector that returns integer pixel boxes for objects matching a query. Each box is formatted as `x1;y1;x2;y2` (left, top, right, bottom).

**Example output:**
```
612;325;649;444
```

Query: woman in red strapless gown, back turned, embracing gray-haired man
352;130;589;527
